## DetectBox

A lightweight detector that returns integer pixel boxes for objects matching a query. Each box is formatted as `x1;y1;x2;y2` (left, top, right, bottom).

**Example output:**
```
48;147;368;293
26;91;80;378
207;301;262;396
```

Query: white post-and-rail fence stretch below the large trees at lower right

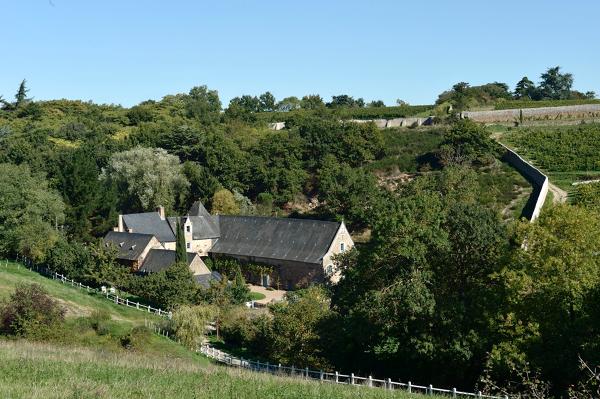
200;344;508;399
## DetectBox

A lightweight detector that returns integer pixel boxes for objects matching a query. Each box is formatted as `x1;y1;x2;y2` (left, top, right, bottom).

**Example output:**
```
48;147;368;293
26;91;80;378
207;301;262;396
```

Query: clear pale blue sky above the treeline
0;0;600;106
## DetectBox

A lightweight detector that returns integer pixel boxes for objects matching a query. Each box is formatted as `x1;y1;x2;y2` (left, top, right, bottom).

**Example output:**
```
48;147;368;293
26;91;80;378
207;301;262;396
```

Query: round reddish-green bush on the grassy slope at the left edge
0;284;65;339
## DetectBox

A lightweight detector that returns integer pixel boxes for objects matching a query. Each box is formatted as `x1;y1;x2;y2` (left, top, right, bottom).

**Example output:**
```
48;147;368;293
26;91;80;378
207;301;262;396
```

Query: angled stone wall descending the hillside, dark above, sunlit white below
501;144;549;222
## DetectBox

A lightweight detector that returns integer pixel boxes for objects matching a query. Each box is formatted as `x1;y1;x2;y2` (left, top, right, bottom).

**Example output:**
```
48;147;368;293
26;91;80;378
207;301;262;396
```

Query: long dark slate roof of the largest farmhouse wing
210;215;340;263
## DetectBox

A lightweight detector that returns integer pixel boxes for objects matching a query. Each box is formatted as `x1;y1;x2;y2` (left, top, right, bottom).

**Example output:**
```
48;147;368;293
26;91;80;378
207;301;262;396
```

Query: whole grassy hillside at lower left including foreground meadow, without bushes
0;261;419;398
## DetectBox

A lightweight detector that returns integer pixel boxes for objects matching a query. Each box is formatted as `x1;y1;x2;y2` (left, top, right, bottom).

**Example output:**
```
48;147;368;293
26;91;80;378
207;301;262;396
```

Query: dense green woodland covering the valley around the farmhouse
0;69;600;397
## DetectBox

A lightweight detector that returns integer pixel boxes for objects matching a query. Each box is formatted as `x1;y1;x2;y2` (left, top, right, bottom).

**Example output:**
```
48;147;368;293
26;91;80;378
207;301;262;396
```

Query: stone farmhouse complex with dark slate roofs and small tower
105;201;354;290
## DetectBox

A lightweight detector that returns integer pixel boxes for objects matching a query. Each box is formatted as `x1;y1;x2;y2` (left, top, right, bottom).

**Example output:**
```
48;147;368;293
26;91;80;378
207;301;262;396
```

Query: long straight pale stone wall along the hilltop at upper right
460;104;600;123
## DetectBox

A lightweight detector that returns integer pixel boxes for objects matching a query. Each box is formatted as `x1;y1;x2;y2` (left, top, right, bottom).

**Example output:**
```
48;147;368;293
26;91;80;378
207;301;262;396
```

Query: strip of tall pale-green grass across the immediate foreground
0;340;421;399
